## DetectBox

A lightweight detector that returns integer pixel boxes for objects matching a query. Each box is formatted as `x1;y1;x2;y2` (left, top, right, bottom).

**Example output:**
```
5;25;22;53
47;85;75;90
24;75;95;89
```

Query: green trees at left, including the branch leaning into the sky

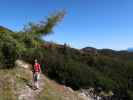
0;11;65;68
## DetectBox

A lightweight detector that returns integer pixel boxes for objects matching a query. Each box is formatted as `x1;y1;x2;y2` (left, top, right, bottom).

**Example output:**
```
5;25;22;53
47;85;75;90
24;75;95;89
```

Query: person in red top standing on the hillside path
33;59;41;89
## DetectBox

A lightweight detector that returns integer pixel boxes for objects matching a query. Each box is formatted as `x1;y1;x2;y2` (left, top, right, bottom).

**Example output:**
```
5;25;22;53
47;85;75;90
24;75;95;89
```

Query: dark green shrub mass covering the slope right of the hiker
32;46;133;100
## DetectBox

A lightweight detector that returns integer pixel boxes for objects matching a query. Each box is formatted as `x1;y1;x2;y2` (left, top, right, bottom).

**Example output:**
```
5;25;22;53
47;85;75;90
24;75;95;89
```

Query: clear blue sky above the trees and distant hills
0;0;133;50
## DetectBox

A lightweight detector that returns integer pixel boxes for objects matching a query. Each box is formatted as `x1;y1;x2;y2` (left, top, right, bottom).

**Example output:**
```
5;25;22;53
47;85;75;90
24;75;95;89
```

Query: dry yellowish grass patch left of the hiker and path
0;68;30;100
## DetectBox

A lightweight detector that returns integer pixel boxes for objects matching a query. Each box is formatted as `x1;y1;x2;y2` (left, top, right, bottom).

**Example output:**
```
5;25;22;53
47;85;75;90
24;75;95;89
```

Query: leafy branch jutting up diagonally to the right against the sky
24;11;65;36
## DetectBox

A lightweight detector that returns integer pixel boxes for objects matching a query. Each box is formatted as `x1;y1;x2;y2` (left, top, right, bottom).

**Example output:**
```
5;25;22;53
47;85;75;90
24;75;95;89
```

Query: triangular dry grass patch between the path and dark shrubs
37;75;82;100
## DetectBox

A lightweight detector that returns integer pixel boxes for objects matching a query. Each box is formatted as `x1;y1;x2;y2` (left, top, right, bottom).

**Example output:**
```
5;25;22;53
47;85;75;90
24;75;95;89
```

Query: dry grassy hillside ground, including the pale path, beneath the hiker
0;61;89;100
